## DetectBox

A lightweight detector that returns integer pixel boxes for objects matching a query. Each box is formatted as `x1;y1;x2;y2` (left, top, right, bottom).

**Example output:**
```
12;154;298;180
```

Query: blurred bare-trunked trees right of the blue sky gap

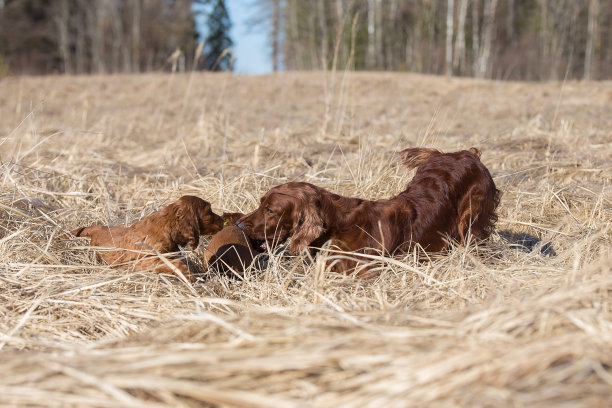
266;0;612;80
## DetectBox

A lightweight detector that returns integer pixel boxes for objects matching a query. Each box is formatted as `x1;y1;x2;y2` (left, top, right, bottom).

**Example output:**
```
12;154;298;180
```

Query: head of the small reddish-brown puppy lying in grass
167;195;223;249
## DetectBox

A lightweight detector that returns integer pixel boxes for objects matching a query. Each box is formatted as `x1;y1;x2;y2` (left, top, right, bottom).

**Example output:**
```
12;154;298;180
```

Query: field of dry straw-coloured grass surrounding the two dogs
0;73;612;407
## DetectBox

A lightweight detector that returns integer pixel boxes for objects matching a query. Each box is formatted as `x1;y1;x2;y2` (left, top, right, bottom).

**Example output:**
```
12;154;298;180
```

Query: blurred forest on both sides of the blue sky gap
0;0;612;81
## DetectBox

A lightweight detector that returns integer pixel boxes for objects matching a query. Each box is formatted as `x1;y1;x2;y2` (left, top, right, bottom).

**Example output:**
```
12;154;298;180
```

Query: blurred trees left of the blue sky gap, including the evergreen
0;0;232;74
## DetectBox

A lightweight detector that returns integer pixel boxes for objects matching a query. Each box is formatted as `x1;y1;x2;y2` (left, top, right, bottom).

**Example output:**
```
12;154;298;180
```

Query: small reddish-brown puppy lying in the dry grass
71;196;223;281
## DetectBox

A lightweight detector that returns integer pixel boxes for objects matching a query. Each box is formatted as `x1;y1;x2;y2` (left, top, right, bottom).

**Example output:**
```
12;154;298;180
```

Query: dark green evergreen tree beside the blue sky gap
204;0;234;71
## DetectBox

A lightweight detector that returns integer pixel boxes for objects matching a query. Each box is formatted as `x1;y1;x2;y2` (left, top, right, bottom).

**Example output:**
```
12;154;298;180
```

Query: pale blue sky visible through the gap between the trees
198;0;272;74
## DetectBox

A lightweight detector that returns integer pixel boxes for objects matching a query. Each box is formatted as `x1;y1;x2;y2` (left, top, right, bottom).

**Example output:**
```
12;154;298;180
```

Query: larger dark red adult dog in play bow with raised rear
236;148;499;272
